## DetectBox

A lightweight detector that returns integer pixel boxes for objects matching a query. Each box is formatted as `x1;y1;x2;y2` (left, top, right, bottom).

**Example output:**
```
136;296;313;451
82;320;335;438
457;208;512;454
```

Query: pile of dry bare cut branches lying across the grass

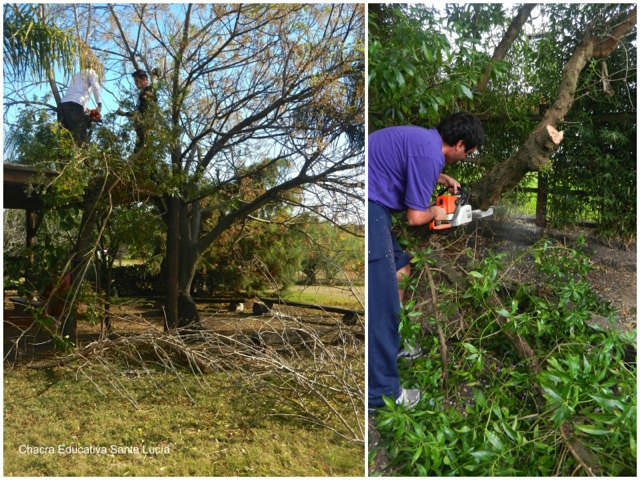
17;314;364;443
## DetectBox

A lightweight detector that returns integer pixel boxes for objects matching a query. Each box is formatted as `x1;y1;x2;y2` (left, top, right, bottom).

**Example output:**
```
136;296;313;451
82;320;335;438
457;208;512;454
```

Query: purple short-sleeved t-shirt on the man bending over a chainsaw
367;126;444;211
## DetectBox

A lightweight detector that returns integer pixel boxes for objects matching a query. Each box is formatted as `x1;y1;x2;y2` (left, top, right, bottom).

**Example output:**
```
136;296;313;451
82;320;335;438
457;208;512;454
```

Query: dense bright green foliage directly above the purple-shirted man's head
368;6;496;129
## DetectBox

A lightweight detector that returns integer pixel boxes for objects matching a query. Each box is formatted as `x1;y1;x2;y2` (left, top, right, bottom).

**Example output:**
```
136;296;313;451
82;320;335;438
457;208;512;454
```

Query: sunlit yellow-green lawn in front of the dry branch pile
4;367;364;477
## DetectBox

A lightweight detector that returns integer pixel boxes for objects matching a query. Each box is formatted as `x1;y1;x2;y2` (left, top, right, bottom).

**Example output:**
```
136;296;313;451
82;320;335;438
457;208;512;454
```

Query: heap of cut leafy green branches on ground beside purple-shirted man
376;237;637;476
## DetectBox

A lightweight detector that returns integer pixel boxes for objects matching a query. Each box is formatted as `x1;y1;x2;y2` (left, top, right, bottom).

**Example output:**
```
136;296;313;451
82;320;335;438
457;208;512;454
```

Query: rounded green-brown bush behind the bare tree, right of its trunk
196;217;364;293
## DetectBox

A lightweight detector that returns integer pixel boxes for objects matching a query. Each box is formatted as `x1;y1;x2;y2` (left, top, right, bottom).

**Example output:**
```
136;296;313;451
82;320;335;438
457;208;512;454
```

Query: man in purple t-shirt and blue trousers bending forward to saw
367;112;484;410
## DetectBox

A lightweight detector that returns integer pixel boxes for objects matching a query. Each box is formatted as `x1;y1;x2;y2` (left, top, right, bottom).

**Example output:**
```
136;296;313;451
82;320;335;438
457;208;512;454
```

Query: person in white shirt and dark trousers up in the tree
58;64;102;147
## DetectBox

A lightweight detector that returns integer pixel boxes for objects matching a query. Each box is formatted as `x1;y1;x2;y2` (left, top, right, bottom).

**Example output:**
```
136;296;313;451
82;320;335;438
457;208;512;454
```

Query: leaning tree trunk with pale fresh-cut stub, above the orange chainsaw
471;6;637;209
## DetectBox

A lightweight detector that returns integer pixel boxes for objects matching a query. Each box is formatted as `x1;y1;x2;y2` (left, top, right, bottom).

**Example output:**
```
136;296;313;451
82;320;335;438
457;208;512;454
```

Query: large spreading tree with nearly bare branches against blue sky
105;5;364;326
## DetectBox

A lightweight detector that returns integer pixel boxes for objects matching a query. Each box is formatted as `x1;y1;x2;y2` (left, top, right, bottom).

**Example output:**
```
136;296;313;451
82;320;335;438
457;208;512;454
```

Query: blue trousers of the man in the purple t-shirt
367;201;409;408
